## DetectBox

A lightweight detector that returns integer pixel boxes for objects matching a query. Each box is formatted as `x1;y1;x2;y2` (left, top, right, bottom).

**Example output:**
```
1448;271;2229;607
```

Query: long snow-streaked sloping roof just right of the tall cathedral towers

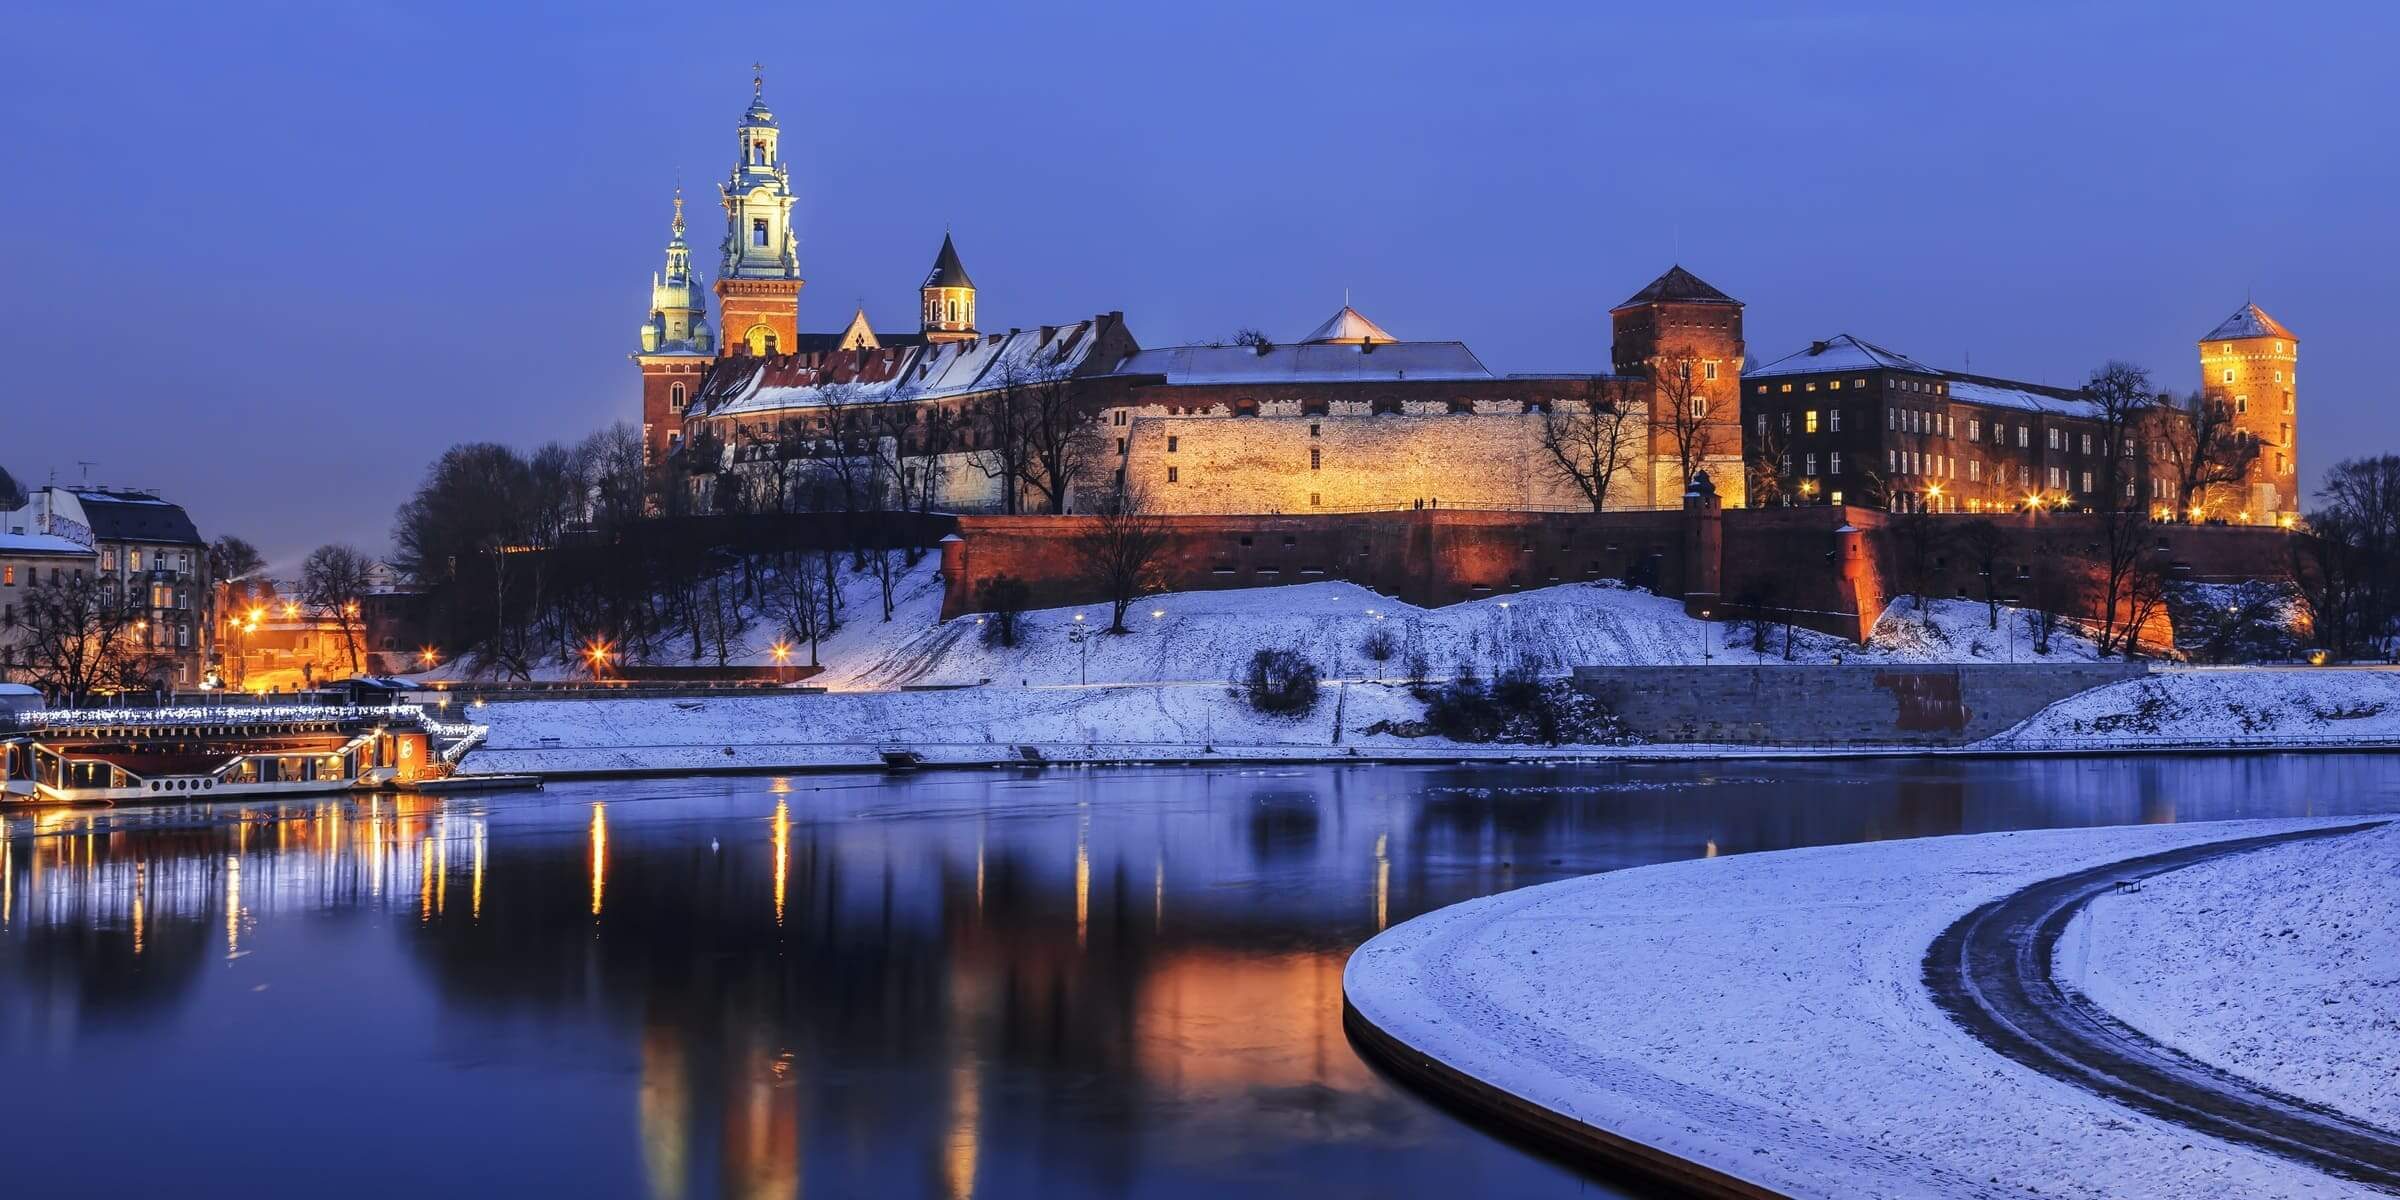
694;317;1114;418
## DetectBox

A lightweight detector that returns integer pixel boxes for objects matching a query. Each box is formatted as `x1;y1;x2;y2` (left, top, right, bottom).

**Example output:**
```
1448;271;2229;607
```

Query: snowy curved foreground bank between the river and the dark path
1344;821;2390;1198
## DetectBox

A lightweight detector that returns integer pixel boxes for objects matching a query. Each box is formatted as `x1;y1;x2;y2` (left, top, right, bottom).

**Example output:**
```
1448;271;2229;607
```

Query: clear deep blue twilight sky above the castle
0;0;2400;566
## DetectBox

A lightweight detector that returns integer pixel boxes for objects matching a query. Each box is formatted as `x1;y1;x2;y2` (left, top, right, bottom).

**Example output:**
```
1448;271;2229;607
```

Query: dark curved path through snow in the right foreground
1925;823;2400;1188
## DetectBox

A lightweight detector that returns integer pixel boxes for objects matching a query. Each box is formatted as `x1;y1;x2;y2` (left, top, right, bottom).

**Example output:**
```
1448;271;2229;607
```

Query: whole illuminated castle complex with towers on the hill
634;79;2299;526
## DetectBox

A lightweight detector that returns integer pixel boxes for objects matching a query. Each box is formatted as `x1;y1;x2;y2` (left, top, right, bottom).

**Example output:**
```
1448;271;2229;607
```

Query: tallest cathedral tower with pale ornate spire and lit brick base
718;77;802;355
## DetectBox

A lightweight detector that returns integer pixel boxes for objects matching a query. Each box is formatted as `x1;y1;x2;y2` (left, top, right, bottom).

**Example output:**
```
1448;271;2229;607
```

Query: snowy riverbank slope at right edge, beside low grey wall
1985;667;2400;749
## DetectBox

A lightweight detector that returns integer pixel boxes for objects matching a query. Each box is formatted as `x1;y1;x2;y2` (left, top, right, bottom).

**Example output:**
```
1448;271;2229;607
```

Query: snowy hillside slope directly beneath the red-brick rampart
425;557;2093;691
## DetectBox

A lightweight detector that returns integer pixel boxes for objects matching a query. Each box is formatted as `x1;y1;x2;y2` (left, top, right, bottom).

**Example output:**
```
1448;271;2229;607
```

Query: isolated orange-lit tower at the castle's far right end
2201;302;2299;526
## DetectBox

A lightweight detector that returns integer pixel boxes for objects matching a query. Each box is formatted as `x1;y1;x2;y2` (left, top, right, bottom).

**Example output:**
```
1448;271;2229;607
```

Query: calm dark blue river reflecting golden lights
0;756;2400;1200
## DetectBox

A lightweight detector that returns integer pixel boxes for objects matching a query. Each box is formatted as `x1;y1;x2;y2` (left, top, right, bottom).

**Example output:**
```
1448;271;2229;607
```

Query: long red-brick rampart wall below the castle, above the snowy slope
943;496;2292;643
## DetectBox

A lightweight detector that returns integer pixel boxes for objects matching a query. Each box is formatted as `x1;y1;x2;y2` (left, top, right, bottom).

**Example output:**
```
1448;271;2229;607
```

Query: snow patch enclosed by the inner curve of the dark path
2059;826;2400;1130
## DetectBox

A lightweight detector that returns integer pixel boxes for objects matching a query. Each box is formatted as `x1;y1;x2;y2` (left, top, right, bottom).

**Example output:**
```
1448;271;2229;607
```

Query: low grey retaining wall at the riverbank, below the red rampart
1574;662;2148;746
